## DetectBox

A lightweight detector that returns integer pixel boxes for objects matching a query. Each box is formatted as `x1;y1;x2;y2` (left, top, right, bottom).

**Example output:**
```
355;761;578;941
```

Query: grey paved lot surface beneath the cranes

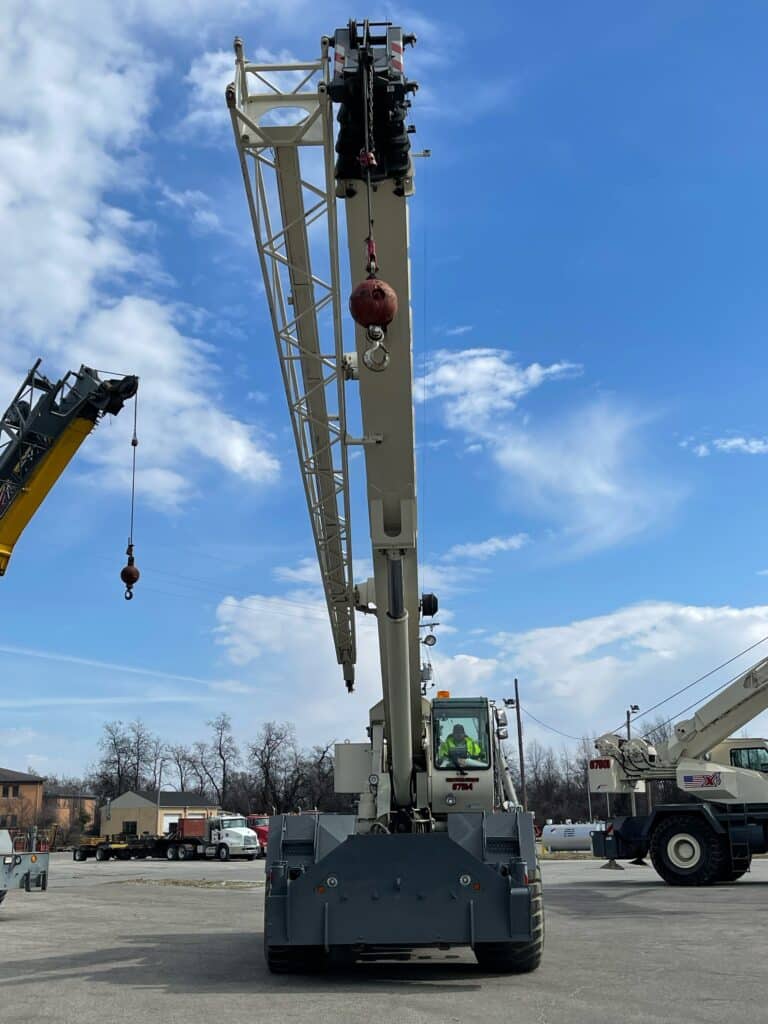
0;854;768;1024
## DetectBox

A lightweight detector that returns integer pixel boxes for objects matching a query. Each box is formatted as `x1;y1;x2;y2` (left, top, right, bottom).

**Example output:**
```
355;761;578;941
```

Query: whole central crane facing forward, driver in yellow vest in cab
226;22;544;973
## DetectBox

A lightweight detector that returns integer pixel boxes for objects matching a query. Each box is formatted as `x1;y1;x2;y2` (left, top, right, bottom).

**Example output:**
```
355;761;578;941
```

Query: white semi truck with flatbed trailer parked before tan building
73;813;262;861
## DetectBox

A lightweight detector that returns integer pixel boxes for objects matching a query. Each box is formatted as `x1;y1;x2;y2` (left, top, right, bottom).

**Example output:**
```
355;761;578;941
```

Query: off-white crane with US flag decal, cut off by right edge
589;658;768;886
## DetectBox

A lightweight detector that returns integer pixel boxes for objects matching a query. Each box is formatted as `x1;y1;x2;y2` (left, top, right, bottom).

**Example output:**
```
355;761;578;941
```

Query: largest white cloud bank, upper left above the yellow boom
0;0;278;507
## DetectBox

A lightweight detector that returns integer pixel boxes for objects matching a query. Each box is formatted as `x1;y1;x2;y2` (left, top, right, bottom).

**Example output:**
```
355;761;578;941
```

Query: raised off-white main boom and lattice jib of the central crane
227;19;434;807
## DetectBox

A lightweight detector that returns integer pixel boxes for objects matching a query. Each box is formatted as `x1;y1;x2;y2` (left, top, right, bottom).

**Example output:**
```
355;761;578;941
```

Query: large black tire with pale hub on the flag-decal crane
650;814;728;886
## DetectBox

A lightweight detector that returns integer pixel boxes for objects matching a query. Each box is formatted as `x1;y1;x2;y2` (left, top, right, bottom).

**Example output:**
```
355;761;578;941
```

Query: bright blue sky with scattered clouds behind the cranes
0;0;768;772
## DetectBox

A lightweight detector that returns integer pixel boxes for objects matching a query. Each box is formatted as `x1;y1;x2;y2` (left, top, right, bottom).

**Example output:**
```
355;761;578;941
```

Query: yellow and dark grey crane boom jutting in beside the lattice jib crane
0;359;138;575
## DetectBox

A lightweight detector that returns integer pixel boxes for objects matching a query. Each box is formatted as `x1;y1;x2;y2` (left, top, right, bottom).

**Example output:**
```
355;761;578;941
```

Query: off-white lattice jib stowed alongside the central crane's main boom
226;39;356;690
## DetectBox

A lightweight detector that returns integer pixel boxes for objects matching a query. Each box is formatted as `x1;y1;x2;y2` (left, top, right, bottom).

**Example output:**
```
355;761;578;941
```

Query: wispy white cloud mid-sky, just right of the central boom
417;348;680;553
